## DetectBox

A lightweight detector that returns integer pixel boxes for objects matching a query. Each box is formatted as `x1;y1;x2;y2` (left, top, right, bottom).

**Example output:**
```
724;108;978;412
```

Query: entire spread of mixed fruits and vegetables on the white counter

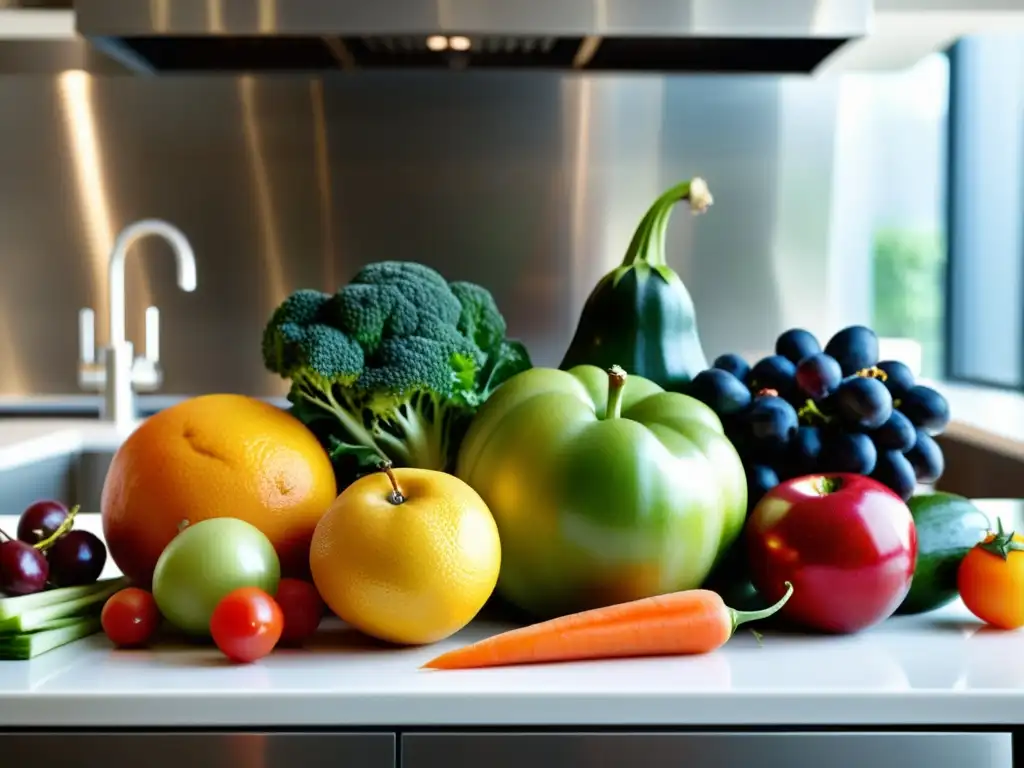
6;179;1024;669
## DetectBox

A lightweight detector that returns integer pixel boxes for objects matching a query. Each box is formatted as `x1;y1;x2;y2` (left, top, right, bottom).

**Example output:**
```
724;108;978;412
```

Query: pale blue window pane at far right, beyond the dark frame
945;36;1024;389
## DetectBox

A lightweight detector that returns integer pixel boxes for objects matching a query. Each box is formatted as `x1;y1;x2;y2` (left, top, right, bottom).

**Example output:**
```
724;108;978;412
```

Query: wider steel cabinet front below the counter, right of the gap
399;733;1013;768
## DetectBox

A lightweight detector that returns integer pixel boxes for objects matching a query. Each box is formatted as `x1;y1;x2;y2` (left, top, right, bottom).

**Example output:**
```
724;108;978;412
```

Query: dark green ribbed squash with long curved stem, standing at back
558;178;712;392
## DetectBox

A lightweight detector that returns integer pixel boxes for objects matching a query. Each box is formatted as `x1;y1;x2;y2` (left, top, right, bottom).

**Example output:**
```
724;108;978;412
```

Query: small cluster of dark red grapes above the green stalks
0;500;106;597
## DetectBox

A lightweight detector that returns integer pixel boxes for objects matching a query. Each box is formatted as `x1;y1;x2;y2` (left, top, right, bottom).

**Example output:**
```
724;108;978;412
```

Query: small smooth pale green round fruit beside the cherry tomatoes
153;517;281;636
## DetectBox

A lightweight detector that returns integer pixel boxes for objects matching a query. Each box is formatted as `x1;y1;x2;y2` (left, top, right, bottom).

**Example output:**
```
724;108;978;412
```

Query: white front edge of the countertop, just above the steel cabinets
6;690;1024;734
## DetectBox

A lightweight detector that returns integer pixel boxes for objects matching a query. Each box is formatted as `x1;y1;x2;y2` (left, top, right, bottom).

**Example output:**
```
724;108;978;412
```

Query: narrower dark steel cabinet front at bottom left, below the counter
0;732;395;768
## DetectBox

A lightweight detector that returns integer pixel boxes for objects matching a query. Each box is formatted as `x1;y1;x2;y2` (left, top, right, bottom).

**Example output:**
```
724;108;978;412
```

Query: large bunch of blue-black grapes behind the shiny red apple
687;326;949;508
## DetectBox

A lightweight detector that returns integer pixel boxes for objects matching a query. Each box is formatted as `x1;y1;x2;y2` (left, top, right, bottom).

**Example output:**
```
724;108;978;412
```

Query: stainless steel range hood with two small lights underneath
74;0;872;74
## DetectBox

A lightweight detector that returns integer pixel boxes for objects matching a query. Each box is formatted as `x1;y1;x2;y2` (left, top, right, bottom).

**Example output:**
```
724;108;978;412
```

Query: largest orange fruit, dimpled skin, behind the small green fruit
100;394;337;587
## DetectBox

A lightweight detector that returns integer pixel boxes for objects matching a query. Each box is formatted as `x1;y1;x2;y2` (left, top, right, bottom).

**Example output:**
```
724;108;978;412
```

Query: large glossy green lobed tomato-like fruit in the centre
456;366;746;617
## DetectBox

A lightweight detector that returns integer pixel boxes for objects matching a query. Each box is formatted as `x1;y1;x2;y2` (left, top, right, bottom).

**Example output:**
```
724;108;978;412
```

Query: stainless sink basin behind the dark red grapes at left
0;451;114;515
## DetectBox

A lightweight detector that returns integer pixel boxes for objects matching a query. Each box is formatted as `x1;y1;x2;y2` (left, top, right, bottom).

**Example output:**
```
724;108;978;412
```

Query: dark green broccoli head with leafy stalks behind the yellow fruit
262;261;531;484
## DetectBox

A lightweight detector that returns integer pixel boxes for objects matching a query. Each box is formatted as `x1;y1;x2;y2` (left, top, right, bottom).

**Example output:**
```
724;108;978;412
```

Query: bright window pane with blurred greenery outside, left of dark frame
833;53;950;378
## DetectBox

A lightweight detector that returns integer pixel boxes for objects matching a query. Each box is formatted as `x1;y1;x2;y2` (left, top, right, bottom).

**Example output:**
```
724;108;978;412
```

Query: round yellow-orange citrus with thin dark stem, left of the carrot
309;468;502;645
